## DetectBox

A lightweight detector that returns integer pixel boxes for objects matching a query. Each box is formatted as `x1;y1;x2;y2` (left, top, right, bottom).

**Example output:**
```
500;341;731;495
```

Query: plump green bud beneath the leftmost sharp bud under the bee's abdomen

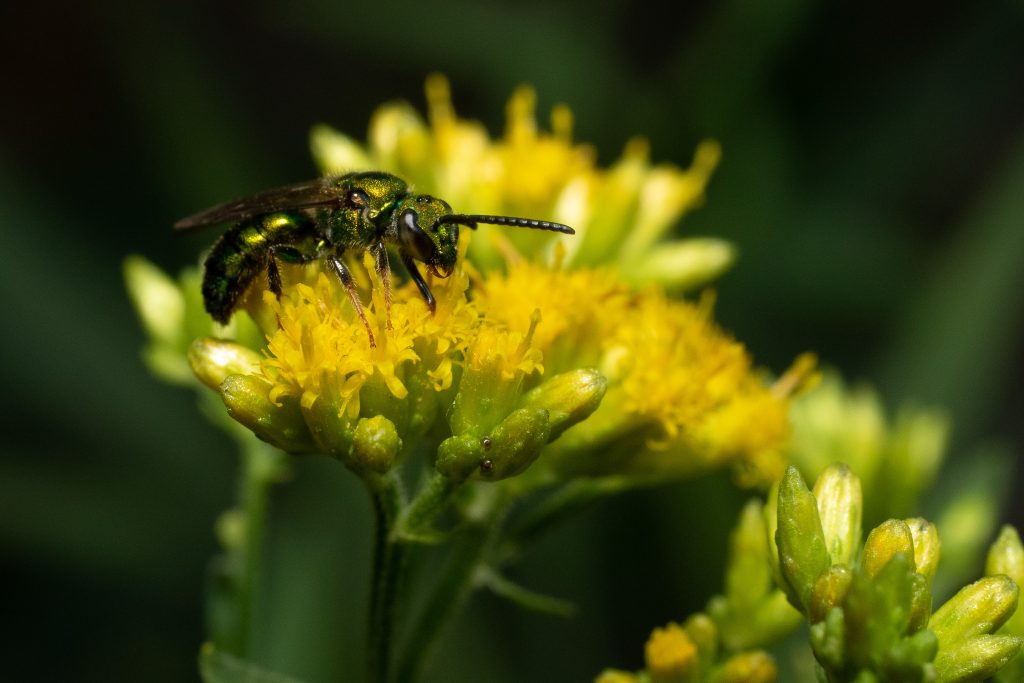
218;375;315;453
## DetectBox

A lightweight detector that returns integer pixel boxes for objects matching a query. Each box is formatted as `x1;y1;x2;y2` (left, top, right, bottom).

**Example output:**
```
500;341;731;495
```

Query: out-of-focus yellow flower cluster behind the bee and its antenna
311;75;734;289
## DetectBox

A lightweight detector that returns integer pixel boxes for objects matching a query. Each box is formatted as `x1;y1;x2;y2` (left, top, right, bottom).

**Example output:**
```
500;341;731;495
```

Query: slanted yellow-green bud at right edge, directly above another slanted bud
928;574;1018;650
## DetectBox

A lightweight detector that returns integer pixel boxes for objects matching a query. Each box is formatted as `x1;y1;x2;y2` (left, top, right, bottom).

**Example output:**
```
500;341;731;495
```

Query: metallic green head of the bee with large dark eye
394;195;459;278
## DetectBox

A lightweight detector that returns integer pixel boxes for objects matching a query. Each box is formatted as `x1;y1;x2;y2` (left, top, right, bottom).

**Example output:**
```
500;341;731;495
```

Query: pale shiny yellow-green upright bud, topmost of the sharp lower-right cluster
814;463;863;564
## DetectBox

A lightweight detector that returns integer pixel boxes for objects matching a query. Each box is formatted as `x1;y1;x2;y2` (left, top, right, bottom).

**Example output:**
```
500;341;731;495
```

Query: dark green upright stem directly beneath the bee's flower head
366;474;404;683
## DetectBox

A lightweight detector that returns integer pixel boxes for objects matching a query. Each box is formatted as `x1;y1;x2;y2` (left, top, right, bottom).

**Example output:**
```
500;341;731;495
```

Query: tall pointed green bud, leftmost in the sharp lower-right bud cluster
775;465;828;613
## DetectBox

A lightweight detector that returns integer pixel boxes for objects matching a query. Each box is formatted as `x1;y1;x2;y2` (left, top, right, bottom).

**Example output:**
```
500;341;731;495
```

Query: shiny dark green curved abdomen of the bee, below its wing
203;214;308;324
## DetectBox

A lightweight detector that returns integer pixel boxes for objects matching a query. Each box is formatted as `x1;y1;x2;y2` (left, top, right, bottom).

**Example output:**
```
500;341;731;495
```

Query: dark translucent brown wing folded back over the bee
174;178;344;230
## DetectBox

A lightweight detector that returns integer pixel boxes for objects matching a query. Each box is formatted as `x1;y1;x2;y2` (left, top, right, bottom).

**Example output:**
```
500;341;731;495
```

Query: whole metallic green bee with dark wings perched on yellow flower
174;171;574;346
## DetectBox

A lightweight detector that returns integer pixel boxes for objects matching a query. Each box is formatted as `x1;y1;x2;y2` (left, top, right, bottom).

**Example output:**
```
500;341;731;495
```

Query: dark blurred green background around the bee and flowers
0;0;1024;683
